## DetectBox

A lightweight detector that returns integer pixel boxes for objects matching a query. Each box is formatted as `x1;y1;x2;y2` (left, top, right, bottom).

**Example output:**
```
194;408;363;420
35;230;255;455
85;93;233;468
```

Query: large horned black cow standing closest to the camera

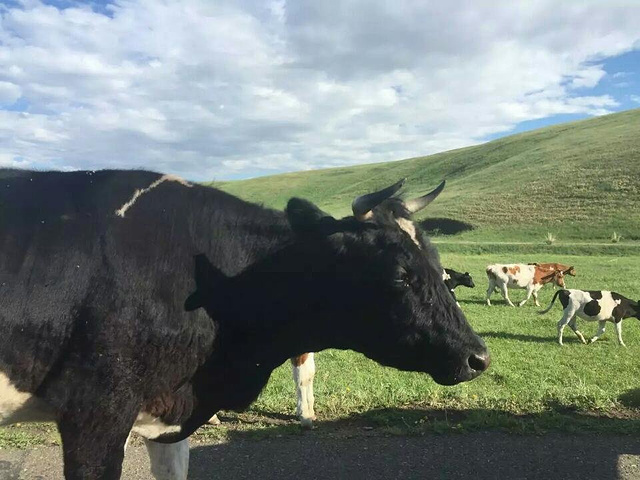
0;170;489;479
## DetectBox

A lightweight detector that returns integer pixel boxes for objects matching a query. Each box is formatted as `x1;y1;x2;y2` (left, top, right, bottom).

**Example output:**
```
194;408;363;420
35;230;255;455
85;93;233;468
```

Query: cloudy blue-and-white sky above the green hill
0;0;640;181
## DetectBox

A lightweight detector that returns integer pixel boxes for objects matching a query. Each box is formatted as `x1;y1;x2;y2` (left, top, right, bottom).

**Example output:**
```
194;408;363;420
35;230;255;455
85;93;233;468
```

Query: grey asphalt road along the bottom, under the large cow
0;432;640;480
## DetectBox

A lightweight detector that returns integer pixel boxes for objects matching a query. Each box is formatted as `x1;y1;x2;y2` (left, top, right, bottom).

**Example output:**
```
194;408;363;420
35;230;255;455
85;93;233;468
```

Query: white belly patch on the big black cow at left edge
0;372;53;425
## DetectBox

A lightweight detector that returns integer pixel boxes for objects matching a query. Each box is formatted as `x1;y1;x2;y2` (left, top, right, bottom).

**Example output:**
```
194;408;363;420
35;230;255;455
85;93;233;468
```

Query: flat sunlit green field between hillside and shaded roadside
228;254;640;433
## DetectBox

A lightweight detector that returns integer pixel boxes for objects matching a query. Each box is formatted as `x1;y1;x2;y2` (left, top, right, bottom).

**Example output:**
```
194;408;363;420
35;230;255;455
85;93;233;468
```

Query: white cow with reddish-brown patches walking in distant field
486;263;575;307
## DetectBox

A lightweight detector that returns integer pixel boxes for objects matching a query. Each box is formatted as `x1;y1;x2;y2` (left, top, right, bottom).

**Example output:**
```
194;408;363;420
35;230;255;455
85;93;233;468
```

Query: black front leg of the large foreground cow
58;398;140;480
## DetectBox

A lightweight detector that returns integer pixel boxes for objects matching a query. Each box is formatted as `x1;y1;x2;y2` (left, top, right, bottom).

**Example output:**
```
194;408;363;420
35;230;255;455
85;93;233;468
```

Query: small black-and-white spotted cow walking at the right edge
540;289;640;347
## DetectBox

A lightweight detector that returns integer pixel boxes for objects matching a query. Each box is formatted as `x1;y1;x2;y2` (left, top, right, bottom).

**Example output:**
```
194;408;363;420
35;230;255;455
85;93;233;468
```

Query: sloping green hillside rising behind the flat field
212;109;640;242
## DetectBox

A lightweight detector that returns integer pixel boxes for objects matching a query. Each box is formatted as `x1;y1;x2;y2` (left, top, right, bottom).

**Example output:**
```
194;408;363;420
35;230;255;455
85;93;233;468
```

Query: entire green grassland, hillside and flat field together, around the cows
0;110;640;448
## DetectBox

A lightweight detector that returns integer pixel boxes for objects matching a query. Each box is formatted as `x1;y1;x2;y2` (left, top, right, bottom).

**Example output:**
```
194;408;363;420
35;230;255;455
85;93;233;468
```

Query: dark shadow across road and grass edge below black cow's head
189;403;640;480
